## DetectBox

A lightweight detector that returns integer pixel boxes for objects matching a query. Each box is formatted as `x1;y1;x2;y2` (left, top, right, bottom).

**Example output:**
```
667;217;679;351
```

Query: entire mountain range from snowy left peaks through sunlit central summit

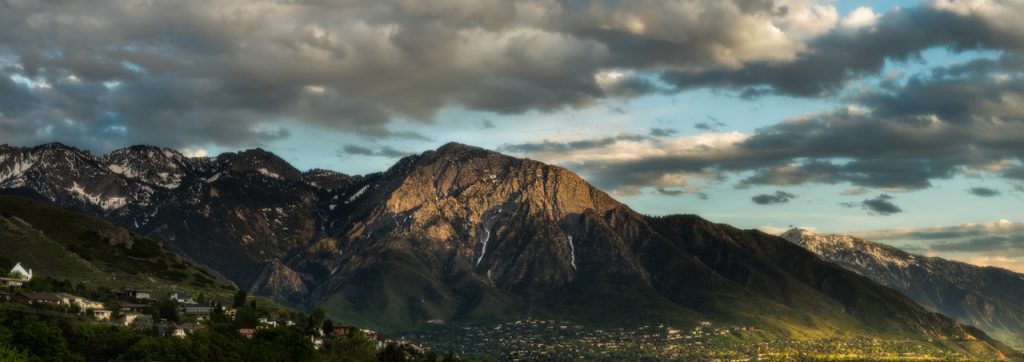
0;143;1012;356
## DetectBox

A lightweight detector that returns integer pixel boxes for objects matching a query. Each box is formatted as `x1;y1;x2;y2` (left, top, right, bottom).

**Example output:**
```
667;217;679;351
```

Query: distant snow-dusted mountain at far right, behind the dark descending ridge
781;229;1024;347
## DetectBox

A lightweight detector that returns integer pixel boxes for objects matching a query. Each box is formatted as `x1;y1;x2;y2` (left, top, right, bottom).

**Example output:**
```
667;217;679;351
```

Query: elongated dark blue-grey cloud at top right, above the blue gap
662;1;1024;98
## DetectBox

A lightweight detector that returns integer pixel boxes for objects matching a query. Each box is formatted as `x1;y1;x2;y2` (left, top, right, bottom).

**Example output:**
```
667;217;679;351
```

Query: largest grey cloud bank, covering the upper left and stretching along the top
0;0;1022;148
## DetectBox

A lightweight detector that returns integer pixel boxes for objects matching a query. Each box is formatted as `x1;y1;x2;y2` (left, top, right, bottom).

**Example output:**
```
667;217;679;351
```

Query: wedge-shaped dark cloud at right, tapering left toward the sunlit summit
507;56;1024;195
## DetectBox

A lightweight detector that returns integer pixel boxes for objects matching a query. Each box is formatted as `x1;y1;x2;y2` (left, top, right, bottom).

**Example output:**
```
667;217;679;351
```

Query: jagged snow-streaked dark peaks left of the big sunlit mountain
0;143;327;300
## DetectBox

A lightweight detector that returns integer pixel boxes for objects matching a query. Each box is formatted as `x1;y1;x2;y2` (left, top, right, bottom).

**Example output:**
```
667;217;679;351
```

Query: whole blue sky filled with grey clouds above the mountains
0;0;1024;272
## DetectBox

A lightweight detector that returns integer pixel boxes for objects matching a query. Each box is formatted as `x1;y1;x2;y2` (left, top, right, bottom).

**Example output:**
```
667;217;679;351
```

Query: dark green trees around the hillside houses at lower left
0;278;461;362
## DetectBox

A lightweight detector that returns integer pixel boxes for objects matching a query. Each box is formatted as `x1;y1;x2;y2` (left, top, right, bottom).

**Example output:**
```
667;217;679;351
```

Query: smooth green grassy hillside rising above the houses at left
0;196;236;297
